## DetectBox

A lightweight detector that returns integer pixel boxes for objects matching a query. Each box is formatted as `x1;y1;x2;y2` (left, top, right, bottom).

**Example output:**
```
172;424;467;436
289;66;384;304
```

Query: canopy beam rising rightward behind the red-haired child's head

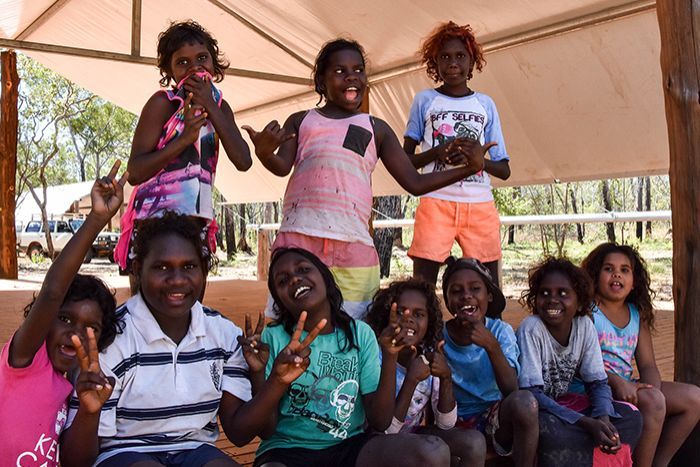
237;0;656;115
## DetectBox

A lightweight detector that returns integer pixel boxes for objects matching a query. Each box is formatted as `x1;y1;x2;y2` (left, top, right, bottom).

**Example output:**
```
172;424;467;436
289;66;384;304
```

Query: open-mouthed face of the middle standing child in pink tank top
323;49;367;113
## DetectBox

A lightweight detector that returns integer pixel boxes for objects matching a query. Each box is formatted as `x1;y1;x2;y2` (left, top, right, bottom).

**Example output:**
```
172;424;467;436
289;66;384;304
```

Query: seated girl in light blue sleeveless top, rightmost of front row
581;243;700;466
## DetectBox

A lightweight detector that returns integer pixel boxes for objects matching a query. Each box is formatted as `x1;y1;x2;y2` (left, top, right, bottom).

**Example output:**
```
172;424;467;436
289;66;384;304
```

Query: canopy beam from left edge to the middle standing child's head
0;38;311;86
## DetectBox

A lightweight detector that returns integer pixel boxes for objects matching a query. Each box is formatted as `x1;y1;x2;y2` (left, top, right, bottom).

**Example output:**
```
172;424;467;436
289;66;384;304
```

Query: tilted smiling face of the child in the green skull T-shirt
270;252;328;319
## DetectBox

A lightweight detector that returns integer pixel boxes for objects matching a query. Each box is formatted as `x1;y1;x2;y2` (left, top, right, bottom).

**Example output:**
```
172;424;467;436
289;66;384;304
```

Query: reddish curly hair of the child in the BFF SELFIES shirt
418;21;486;83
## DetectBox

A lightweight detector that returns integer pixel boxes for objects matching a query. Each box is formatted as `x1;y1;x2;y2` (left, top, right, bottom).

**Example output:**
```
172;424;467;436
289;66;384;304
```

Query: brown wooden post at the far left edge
0;50;19;279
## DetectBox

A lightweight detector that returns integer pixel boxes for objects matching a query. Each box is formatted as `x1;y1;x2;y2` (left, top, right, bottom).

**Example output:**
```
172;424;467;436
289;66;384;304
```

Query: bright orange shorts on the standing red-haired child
408;198;501;263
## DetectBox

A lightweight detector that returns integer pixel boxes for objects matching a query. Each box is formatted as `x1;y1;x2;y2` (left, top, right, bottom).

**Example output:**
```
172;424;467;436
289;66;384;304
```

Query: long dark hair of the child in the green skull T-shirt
267;248;360;351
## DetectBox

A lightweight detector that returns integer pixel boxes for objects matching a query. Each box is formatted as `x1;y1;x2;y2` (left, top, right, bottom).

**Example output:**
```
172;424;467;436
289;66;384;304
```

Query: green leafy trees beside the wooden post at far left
16;54;135;257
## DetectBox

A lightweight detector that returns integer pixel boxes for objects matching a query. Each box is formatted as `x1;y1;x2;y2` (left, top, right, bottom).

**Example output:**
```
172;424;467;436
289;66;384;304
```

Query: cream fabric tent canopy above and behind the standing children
0;0;669;202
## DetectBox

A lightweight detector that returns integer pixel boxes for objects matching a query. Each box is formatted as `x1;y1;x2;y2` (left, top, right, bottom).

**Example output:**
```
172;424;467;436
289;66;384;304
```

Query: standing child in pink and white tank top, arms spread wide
243;39;493;317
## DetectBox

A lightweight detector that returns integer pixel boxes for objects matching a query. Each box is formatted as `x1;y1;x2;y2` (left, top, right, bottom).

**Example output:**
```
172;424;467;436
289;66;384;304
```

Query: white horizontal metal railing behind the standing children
246;211;671;231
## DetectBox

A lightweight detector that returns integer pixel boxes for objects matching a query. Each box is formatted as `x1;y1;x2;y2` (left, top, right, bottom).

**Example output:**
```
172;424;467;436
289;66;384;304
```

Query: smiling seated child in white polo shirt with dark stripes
62;213;256;467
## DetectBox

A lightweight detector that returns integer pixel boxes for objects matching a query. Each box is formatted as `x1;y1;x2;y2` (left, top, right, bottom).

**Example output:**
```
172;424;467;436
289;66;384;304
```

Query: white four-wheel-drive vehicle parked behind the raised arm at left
17;219;119;263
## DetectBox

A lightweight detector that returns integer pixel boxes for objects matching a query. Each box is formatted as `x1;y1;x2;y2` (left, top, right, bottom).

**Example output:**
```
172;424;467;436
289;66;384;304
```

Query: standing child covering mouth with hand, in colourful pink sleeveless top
115;21;252;278
